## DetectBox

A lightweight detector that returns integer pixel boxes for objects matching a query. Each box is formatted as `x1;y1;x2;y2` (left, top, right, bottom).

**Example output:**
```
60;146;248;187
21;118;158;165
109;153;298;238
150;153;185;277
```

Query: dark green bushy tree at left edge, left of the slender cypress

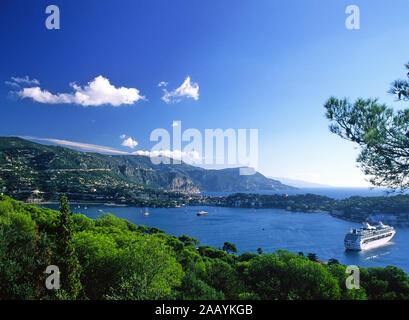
0;197;51;300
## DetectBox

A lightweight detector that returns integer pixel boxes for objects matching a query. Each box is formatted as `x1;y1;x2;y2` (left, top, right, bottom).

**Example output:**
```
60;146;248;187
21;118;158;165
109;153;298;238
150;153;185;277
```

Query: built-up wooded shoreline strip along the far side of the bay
0;185;409;225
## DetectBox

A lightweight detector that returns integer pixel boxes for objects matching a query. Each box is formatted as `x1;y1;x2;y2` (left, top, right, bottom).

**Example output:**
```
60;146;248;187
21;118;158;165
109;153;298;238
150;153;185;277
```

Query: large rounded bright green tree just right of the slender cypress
73;228;183;300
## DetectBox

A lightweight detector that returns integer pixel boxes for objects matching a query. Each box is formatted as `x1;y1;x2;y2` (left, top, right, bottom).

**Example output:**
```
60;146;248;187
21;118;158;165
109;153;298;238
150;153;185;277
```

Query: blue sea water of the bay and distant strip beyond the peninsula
40;188;409;273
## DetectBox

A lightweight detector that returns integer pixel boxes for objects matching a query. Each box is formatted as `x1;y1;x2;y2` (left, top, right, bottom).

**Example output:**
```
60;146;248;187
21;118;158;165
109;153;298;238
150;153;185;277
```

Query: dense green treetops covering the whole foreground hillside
0;196;409;299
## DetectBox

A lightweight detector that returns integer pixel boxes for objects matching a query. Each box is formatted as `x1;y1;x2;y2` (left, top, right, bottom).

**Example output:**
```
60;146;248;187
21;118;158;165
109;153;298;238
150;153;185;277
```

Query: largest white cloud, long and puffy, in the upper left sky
19;76;145;107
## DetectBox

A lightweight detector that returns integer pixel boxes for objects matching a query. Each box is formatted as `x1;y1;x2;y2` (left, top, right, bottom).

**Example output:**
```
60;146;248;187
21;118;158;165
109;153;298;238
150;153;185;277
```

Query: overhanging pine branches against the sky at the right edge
325;64;409;189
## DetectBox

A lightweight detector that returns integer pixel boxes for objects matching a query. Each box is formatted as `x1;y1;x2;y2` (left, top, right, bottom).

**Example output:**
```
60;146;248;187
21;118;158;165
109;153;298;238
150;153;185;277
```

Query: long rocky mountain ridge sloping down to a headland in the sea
0;137;293;194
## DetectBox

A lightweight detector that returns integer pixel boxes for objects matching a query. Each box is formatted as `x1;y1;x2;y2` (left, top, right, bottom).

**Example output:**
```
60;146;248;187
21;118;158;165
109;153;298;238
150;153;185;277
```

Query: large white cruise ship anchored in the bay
344;222;396;251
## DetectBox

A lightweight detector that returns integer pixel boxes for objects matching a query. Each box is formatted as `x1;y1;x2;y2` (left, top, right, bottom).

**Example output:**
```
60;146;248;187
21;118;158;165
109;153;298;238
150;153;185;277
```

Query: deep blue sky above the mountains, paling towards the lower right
0;0;409;186
